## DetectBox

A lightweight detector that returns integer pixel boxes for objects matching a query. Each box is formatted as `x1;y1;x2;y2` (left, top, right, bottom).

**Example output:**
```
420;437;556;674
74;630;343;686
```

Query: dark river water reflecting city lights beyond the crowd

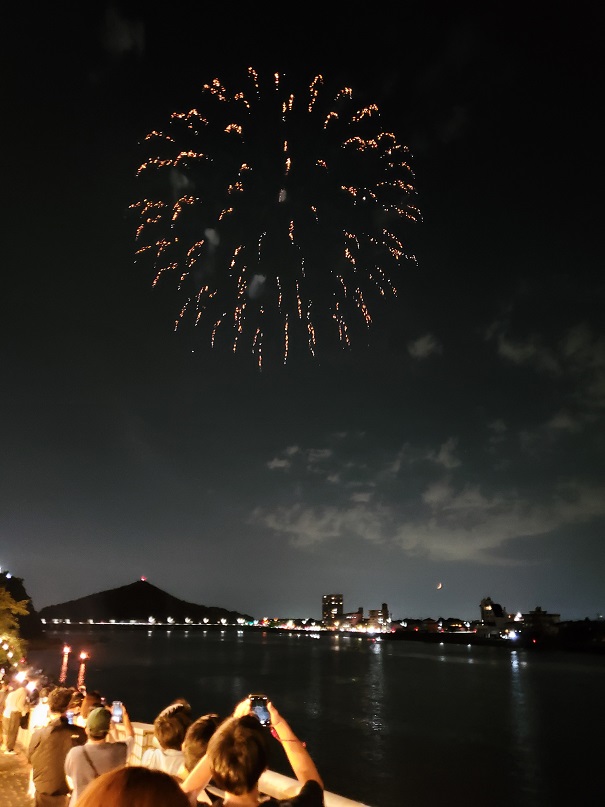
30;628;605;807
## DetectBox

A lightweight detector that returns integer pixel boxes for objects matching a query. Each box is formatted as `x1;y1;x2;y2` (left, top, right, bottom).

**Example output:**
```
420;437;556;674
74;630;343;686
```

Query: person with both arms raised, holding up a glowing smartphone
182;696;323;807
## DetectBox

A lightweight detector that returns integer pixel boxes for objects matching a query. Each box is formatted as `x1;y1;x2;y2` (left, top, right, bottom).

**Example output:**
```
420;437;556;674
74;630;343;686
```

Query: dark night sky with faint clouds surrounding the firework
0;0;605;619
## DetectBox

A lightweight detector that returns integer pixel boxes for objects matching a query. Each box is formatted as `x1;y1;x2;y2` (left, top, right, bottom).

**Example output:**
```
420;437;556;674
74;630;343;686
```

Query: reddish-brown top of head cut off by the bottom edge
78;765;189;807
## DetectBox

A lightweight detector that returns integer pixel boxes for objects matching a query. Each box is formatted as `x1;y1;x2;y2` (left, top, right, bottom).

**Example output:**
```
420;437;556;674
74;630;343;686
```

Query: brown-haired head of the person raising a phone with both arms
206;715;269;796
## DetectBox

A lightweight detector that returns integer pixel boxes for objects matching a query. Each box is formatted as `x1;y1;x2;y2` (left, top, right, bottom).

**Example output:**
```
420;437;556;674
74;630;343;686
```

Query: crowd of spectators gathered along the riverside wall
0;680;323;807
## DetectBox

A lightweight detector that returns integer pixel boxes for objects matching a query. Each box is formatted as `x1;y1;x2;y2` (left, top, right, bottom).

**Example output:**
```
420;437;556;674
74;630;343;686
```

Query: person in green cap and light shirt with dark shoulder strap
65;704;134;807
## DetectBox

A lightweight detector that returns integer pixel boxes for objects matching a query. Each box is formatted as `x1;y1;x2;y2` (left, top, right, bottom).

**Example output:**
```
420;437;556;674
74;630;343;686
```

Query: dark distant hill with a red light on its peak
39;580;252;624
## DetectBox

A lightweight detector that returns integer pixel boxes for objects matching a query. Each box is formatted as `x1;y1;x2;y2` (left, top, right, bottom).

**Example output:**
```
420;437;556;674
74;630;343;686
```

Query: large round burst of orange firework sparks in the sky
131;68;420;368
